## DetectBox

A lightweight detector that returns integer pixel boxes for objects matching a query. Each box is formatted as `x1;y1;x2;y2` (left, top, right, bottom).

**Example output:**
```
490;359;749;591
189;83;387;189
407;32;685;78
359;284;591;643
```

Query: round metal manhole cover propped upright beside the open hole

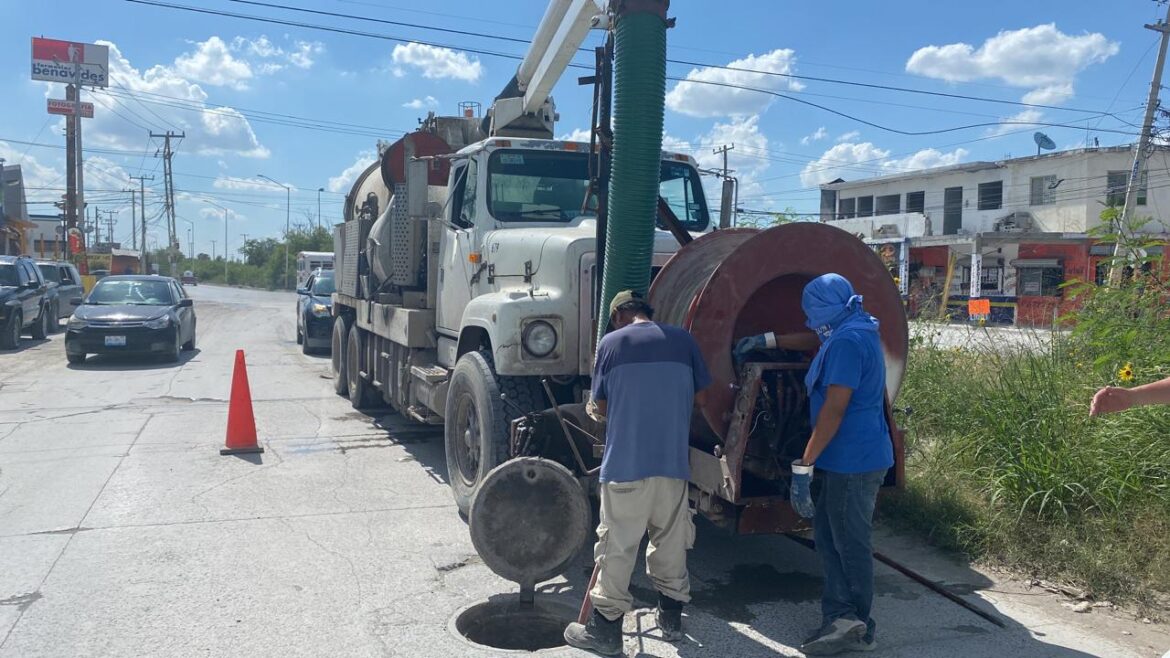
468;457;592;591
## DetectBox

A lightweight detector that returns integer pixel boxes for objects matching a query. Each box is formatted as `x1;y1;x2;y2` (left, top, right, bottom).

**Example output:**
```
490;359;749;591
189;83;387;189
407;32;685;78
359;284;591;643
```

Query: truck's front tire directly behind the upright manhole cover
443;350;543;516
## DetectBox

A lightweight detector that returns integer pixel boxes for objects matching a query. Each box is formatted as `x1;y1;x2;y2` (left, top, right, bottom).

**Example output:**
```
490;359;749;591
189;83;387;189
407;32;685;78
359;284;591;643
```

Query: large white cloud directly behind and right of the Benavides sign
81;41;270;158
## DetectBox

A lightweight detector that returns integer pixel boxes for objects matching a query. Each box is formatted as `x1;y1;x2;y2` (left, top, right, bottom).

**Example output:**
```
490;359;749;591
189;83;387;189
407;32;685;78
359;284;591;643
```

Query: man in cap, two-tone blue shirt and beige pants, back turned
565;290;711;656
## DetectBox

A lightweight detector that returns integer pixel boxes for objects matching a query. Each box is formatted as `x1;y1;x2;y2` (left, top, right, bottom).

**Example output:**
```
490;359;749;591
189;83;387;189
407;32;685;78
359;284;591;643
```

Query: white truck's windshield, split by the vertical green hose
488;149;708;232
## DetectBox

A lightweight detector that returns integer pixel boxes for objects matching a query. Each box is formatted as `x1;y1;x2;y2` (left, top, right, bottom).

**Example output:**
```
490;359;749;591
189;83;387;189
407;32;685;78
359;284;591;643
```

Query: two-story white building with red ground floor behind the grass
820;146;1170;325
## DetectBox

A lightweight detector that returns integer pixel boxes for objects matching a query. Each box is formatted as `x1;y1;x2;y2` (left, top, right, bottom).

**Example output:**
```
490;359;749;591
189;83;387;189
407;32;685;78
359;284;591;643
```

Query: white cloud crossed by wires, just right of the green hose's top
666;48;804;117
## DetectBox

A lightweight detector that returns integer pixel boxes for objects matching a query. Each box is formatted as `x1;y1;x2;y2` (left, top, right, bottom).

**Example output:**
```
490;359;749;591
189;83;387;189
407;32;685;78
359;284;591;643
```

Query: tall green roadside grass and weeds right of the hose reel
881;304;1170;608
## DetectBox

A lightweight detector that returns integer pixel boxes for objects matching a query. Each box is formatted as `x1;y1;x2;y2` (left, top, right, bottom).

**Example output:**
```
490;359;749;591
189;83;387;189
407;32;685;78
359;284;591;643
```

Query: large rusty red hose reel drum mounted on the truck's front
649;222;909;439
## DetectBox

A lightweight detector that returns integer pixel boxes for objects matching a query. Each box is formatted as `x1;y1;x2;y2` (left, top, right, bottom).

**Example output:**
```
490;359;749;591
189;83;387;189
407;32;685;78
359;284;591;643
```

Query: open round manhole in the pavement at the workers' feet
450;595;577;651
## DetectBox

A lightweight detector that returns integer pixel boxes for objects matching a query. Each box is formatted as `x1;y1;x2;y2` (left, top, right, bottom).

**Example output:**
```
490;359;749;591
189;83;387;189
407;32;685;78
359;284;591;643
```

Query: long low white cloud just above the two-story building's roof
800;142;968;187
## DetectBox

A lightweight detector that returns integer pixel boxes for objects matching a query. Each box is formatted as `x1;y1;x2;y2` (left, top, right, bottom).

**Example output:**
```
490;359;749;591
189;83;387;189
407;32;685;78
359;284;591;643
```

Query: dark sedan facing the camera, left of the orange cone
66;275;195;364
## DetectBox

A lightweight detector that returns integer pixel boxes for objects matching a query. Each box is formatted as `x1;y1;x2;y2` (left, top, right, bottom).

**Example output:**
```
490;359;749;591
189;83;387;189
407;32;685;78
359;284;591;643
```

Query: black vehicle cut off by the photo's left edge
0;255;57;350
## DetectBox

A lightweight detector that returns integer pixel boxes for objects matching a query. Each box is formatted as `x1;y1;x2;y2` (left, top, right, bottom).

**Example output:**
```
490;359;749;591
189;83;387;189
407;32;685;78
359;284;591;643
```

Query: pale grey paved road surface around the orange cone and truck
0;287;1170;658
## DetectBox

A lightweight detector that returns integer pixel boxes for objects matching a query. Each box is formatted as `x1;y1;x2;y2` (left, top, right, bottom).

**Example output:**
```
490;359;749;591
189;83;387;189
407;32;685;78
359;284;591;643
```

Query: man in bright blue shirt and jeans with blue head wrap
736;274;894;656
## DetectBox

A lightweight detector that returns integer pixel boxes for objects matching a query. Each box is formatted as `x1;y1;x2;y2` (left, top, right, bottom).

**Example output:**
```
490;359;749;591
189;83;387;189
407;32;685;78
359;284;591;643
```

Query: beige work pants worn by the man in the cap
590;478;695;619
